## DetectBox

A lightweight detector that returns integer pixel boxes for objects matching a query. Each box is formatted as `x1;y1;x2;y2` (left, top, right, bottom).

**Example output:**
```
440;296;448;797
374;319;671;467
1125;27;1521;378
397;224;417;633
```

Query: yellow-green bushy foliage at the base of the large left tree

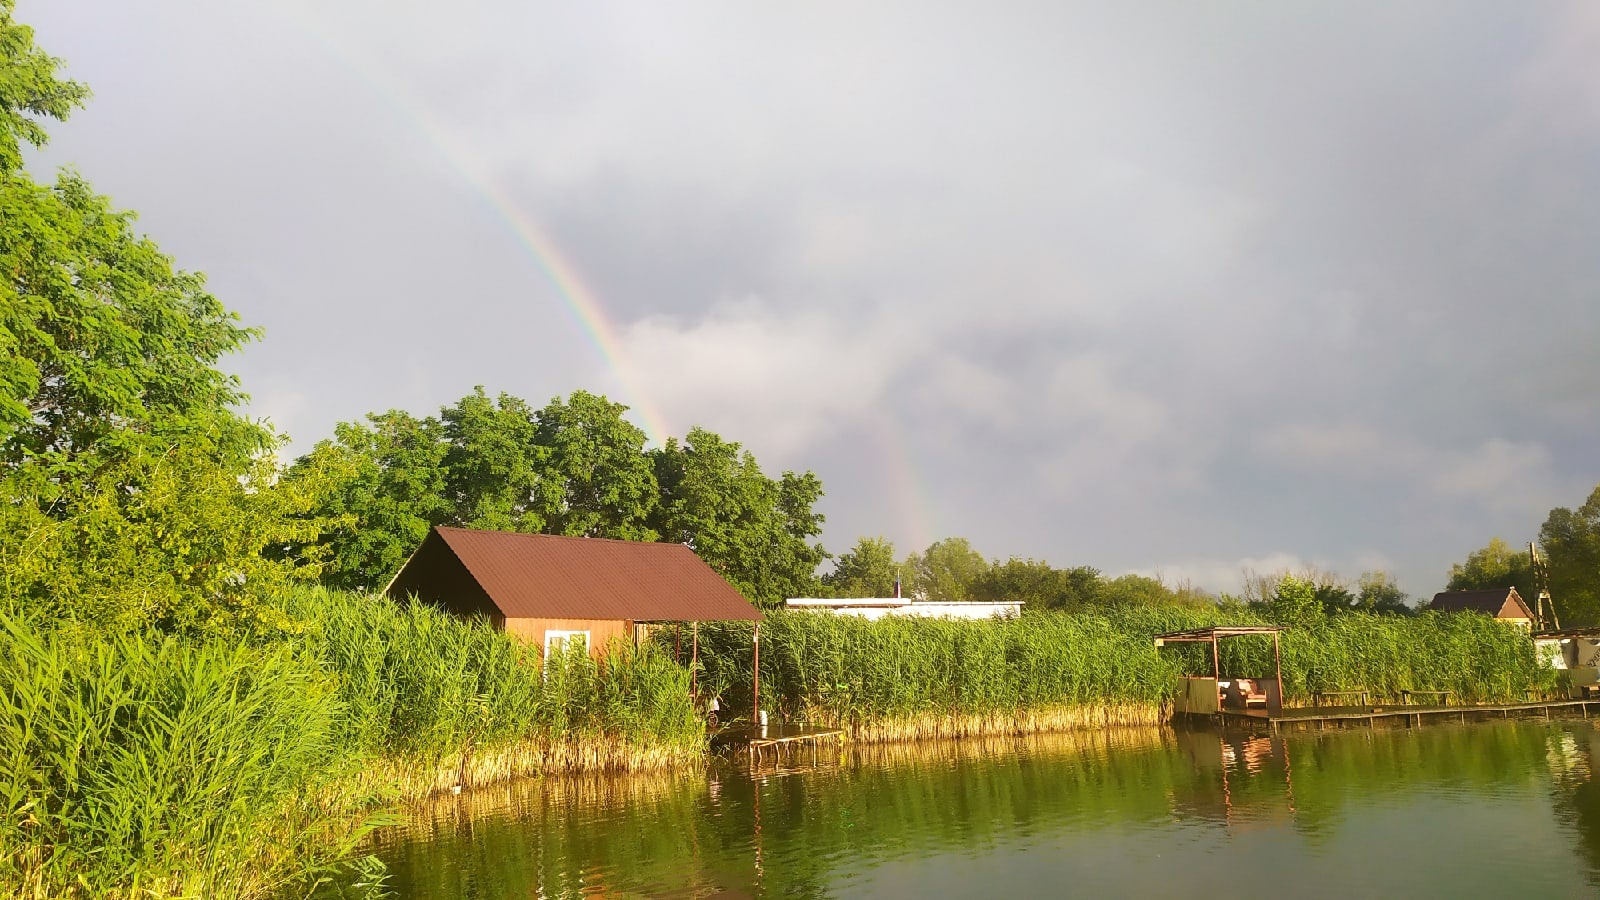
0;452;329;633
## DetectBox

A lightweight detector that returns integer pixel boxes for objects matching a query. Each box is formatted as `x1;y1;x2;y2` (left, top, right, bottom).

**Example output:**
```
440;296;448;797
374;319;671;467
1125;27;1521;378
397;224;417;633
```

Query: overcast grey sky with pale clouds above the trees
16;0;1600;596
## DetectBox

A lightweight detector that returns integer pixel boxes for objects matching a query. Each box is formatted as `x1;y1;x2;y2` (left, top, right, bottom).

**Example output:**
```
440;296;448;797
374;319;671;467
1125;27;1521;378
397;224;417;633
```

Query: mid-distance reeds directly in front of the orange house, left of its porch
285;589;704;762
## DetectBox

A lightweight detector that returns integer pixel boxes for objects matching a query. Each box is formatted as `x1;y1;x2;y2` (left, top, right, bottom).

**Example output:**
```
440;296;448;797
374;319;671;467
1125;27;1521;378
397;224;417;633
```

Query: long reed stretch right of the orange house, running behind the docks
701;609;1554;740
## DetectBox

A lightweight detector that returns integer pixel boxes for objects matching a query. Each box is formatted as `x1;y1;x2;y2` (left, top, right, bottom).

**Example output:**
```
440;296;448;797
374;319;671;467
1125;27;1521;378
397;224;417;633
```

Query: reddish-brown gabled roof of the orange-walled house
389;525;762;621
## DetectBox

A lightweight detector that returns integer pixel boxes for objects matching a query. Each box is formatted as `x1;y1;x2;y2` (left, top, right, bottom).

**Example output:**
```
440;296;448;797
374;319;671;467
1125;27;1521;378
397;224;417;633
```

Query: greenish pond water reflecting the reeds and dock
356;721;1600;900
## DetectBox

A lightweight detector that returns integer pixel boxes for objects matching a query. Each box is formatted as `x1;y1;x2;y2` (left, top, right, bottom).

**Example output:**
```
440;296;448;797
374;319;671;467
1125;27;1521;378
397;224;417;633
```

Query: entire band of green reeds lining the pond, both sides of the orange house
0;589;1554;897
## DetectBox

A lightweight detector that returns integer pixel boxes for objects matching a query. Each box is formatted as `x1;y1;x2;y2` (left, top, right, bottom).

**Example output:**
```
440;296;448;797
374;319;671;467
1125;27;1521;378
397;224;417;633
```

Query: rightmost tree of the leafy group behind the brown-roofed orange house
651;428;824;609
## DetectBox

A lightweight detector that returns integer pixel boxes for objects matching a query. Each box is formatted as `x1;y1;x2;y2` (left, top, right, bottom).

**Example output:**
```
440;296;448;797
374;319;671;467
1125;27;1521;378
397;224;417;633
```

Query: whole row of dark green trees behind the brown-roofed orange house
290;388;822;605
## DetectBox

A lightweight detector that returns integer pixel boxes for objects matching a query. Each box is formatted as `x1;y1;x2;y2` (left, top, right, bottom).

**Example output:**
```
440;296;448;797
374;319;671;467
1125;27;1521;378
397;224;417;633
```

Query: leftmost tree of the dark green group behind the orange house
286;410;454;591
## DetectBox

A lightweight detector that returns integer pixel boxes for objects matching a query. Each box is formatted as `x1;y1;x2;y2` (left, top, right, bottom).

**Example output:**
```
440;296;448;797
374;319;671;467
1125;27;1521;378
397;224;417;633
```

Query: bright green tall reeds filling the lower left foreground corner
0;605;350;897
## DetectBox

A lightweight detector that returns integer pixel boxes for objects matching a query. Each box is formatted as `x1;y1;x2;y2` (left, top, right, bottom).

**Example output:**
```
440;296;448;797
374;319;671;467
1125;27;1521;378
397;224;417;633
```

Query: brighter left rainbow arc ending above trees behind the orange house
274;8;670;447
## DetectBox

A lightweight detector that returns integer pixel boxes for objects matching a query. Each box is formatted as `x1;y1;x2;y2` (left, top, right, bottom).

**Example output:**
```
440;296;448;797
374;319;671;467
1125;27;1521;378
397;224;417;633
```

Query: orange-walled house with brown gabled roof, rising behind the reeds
384;527;762;658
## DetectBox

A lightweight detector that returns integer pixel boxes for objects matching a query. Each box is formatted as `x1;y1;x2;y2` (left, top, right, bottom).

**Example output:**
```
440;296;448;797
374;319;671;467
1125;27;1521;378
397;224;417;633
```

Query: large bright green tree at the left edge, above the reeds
0;0;308;629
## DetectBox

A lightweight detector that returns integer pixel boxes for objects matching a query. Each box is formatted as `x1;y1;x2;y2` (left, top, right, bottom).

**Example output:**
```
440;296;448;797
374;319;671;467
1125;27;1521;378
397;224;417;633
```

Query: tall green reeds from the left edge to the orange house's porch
0;591;704;897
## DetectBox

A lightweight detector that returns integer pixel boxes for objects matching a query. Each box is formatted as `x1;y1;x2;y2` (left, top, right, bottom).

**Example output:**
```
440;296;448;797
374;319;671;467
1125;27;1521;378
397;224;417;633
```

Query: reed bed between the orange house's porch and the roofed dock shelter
701;612;1178;740
